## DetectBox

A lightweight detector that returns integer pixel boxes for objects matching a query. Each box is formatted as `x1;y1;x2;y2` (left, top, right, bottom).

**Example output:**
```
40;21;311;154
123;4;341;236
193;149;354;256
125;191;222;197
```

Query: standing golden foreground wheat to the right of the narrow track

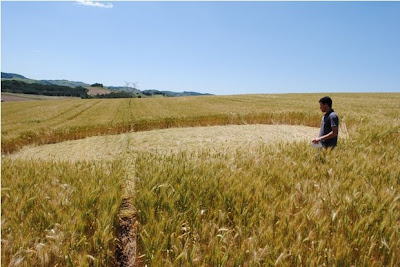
135;125;400;266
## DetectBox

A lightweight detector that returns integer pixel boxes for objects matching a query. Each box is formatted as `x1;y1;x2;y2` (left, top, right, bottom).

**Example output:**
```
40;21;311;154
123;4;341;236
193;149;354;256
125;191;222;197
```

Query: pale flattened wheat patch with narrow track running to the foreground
8;125;319;266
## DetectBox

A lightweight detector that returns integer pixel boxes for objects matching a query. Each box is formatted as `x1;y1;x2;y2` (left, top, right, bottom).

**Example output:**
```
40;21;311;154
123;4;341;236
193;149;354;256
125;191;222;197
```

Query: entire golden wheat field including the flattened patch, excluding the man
1;93;400;266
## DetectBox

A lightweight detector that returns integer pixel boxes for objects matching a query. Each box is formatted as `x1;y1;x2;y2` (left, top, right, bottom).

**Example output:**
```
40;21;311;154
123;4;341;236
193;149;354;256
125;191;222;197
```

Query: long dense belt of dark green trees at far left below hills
1;80;88;98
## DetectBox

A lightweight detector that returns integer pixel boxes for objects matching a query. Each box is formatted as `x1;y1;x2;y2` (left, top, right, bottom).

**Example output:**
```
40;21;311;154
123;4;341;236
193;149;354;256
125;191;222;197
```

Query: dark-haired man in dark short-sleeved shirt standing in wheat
312;96;339;148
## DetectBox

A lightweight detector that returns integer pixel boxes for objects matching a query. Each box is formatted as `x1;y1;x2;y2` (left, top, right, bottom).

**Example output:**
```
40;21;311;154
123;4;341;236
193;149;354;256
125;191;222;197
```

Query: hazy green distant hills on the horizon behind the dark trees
1;72;211;97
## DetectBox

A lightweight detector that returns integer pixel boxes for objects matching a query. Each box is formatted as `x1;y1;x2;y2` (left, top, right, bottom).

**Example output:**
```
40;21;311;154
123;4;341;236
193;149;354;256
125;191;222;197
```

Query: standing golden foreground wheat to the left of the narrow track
1;159;123;266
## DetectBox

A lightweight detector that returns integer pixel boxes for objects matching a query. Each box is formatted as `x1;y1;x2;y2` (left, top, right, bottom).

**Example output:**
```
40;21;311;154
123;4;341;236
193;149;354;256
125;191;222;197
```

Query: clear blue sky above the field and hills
1;1;400;94
